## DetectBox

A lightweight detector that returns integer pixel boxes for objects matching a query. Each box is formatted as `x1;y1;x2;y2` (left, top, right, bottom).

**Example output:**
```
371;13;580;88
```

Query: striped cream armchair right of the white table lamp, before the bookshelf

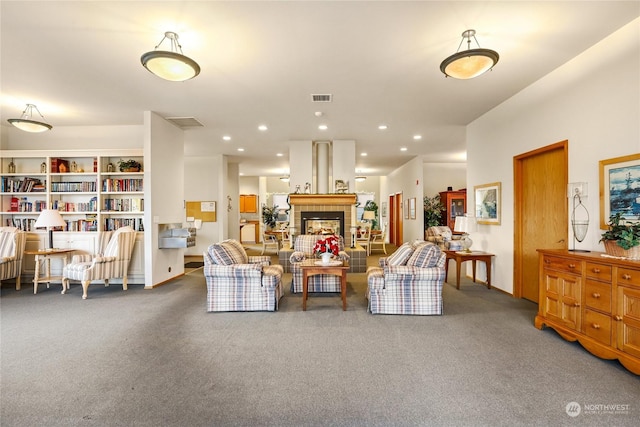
62;227;136;299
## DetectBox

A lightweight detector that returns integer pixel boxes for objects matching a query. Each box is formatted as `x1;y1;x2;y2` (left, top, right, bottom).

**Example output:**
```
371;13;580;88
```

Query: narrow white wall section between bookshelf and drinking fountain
143;111;185;288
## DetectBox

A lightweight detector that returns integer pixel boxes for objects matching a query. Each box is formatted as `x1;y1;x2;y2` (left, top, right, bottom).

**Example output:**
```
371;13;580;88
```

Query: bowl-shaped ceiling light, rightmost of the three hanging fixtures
440;30;500;80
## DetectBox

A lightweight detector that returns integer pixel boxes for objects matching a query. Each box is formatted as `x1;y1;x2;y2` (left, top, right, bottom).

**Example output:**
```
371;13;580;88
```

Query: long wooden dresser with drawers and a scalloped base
535;249;640;375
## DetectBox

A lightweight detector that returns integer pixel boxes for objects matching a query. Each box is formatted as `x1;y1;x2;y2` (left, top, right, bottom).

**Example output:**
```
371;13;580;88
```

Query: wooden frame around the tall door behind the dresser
513;140;569;298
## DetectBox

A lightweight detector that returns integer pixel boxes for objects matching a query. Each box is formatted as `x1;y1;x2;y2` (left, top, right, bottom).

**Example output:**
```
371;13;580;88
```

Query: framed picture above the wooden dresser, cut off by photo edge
599;154;640;230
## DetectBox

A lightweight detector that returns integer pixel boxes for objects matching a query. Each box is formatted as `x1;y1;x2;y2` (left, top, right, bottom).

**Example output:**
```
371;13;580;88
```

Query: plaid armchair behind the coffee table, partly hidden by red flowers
289;234;350;293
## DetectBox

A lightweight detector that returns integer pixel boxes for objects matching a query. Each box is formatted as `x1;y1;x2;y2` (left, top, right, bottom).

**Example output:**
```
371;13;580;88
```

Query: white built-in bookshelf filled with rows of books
0;150;144;232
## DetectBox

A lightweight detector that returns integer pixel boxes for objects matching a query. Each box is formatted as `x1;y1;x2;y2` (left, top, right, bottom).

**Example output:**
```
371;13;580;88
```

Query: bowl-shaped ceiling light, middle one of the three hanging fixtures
140;31;200;82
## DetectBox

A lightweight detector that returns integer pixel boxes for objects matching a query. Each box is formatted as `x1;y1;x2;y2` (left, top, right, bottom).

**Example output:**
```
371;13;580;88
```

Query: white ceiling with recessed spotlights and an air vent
0;0;640;176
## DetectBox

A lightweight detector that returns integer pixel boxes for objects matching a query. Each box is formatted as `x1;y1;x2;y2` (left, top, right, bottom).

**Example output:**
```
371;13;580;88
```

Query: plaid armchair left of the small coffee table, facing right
203;239;284;311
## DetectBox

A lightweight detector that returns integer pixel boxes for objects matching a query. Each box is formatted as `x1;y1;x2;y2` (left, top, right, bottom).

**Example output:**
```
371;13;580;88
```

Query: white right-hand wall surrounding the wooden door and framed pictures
467;19;640;293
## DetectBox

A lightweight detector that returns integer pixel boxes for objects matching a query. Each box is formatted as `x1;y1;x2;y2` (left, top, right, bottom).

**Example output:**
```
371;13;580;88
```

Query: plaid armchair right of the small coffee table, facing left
367;241;446;315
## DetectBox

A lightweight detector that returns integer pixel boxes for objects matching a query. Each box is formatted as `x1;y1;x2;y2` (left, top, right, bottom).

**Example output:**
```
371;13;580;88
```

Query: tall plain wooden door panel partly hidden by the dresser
513;141;569;302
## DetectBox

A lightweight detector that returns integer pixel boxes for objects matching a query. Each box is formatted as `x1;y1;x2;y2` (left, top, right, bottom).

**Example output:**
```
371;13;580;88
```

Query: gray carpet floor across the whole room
0;252;640;427
